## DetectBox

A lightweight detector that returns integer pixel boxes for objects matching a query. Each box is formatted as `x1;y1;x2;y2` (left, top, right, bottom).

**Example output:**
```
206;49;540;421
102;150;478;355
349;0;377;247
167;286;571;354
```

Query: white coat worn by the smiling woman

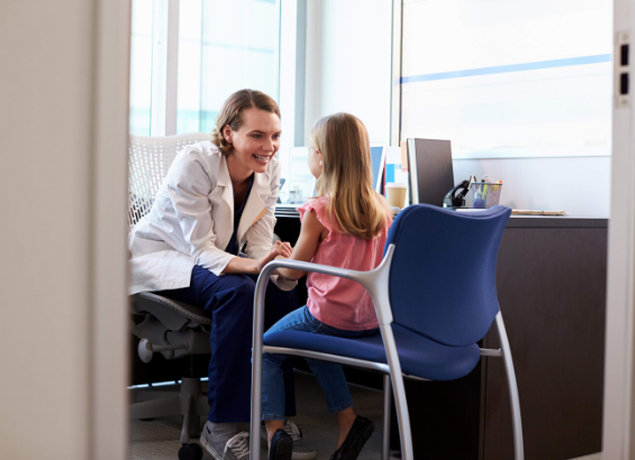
129;141;296;294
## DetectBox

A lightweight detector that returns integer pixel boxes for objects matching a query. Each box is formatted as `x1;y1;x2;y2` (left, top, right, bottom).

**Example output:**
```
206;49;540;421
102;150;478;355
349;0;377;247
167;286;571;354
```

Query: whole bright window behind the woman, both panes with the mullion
130;0;280;136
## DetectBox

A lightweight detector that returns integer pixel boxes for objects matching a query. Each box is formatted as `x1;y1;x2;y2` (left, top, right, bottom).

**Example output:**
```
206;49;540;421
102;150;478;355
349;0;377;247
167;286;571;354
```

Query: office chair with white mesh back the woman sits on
128;133;211;460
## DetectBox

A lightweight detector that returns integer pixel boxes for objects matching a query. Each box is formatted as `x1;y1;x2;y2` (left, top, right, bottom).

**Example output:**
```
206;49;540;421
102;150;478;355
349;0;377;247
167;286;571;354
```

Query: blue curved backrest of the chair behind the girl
386;204;511;346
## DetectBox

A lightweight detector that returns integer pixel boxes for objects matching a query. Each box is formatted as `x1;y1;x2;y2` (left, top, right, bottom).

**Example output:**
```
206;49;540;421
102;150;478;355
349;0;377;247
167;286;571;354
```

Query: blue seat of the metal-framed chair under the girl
264;324;481;380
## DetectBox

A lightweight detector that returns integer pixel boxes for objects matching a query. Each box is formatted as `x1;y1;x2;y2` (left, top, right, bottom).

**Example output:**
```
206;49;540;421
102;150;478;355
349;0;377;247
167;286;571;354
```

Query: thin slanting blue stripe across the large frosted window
401;54;613;84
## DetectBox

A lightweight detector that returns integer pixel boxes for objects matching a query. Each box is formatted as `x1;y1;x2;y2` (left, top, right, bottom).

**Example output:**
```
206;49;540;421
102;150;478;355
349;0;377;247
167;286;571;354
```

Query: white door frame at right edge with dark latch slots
602;0;635;460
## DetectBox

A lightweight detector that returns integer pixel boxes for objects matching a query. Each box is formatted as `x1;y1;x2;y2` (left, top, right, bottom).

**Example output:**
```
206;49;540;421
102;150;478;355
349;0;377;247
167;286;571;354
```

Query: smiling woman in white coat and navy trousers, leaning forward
130;90;315;459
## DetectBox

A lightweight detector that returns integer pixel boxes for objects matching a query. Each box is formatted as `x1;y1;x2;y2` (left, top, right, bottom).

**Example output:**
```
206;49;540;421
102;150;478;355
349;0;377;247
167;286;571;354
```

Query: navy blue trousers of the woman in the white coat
160;266;298;423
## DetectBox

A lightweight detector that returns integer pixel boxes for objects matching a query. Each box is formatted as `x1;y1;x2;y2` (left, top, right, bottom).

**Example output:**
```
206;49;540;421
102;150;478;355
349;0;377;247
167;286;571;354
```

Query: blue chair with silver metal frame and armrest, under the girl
251;204;524;460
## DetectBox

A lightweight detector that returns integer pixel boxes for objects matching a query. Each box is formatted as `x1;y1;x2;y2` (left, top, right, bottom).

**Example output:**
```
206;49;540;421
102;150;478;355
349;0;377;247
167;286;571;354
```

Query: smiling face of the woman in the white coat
223;107;280;176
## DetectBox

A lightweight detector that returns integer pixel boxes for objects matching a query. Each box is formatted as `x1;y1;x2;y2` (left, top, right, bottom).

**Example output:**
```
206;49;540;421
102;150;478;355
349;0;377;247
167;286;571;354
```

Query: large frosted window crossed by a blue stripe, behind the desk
401;0;613;158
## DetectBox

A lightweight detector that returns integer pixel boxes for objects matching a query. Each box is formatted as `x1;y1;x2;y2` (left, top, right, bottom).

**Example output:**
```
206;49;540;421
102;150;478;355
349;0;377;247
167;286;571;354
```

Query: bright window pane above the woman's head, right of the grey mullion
176;0;280;133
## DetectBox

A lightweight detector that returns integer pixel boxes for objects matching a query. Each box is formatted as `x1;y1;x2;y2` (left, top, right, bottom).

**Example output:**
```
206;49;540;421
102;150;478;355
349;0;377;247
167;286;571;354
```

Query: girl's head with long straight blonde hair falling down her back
311;113;390;239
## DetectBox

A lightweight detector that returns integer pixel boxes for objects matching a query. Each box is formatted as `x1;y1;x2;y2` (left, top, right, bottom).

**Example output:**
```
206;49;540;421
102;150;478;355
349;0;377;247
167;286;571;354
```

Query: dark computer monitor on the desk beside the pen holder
407;139;454;206
